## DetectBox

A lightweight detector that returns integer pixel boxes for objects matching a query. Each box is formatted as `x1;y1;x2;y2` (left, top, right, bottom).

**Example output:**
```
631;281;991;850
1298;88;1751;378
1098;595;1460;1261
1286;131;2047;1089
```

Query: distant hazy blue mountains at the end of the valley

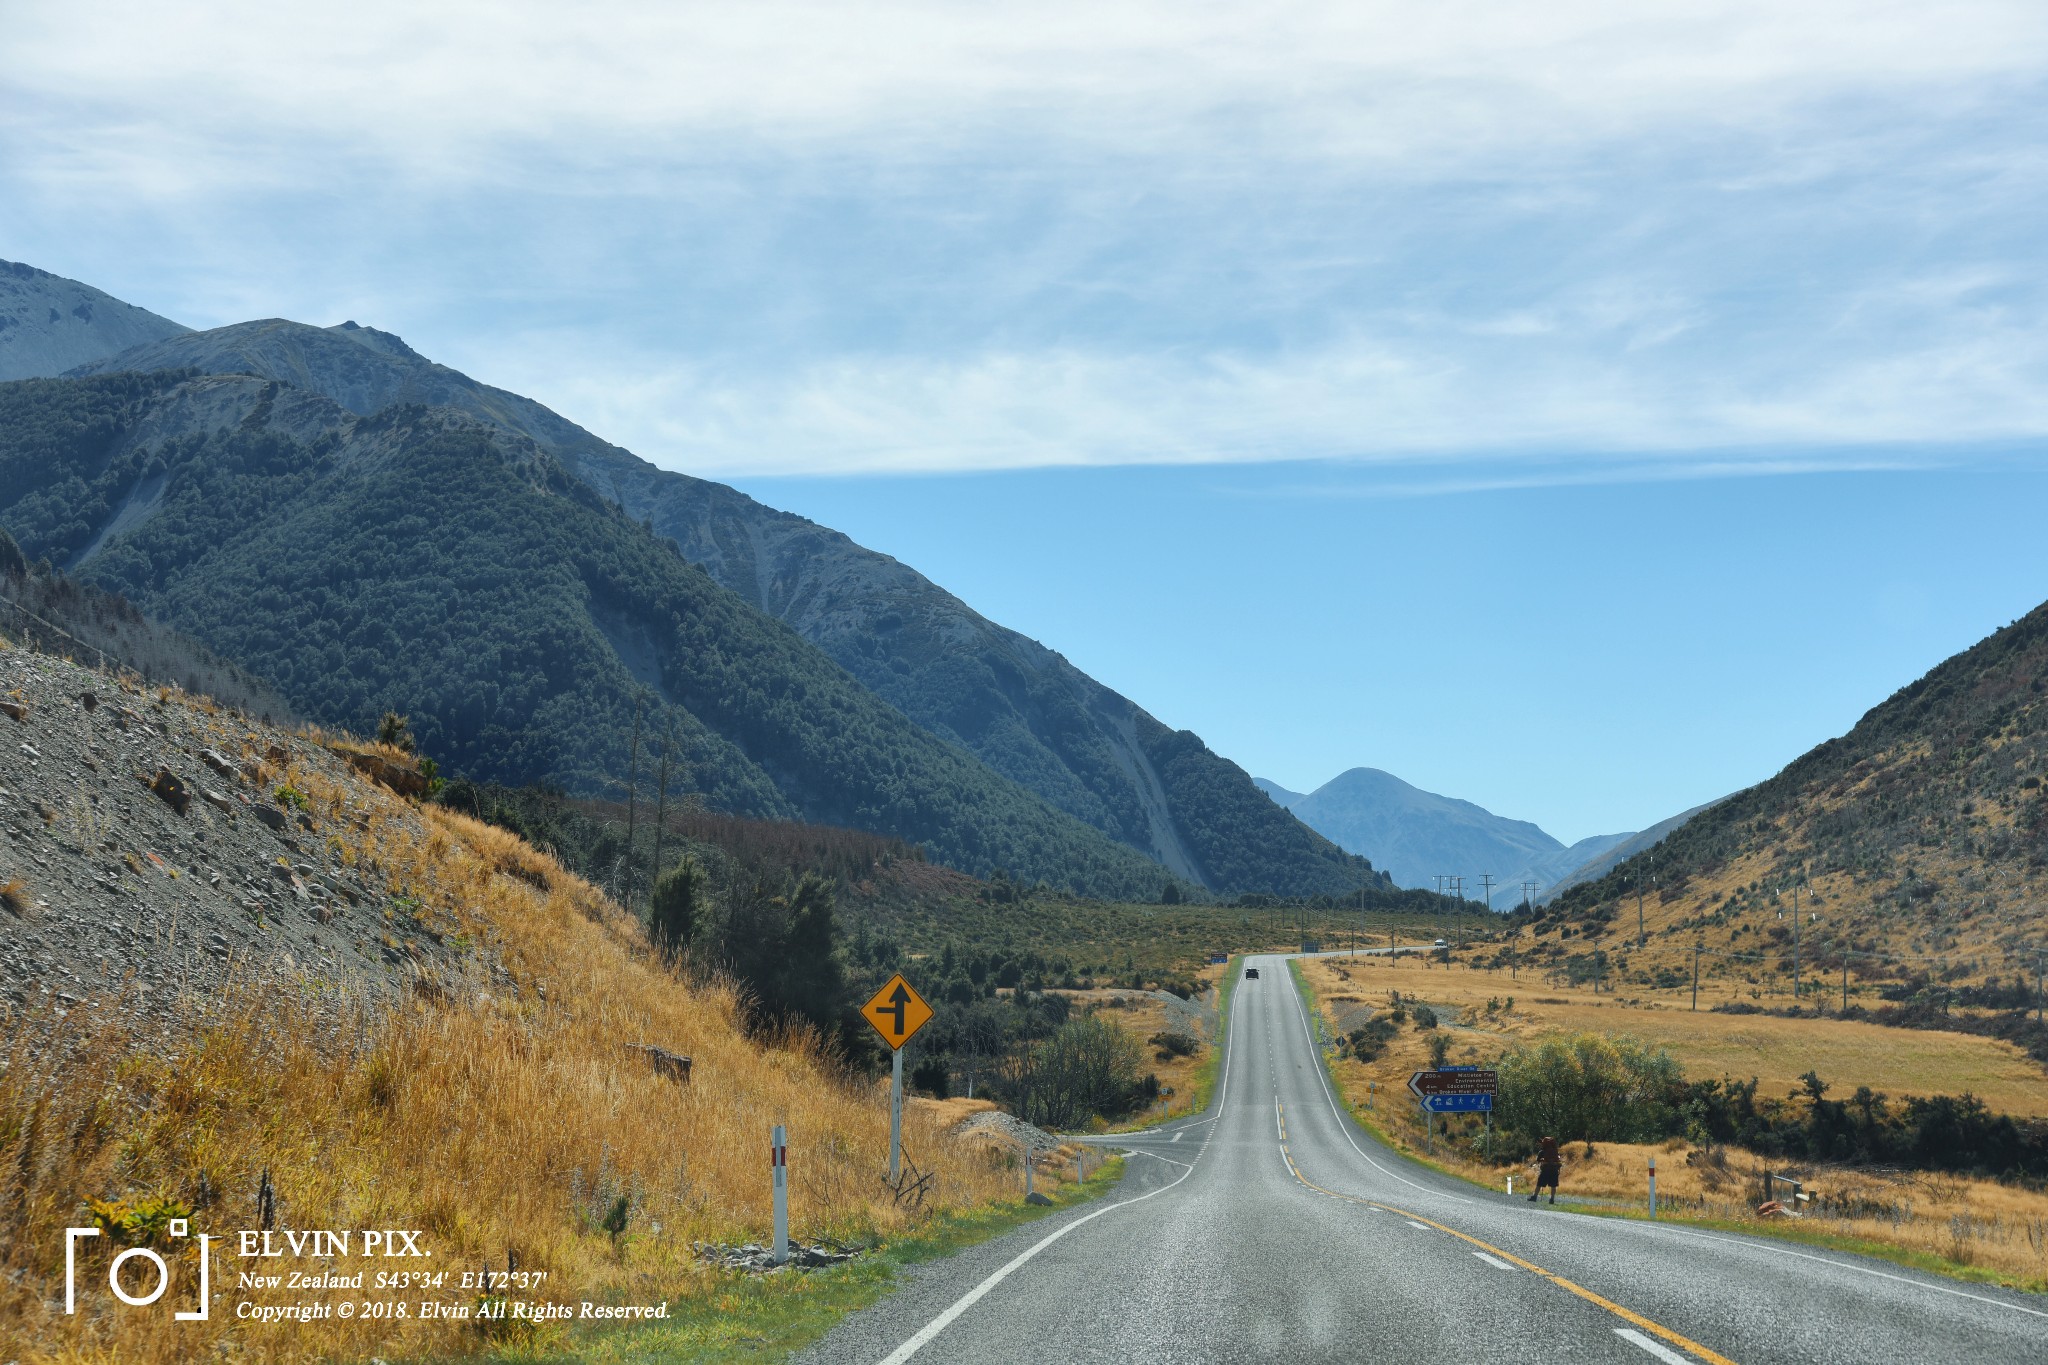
1253;767;1654;911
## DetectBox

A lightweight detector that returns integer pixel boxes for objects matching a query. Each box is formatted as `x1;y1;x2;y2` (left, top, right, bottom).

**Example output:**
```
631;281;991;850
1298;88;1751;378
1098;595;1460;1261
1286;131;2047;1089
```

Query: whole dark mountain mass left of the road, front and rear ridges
0;263;1384;908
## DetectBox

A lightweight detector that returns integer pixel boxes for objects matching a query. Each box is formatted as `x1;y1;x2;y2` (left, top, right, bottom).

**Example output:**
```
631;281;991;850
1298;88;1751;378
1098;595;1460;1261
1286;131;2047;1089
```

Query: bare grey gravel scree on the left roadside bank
0;645;467;1015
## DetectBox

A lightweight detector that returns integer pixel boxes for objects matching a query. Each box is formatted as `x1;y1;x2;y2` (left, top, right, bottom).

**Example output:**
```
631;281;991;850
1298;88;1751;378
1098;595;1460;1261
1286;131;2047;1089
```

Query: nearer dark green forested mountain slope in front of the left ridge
0;372;1167;898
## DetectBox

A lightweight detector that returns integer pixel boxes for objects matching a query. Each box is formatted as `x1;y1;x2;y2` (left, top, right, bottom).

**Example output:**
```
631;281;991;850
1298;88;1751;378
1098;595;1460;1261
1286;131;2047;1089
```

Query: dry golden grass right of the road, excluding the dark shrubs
1303;958;2048;1283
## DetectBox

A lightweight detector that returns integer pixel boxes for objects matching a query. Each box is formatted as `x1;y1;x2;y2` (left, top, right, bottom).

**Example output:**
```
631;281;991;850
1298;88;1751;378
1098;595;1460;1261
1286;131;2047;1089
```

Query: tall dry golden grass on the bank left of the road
0;753;1040;1363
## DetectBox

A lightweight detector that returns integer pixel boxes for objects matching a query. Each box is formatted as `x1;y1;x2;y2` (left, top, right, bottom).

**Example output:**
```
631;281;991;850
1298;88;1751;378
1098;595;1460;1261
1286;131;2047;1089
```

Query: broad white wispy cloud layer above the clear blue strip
0;0;2048;475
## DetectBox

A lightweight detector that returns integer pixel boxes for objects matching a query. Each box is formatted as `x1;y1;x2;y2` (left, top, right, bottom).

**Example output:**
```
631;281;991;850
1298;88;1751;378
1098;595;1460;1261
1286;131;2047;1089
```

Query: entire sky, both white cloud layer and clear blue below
0;0;2048;839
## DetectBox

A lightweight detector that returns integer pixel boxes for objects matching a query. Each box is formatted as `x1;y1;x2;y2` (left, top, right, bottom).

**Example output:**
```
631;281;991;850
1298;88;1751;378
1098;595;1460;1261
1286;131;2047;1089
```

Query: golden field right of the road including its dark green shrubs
1296;958;2048;1289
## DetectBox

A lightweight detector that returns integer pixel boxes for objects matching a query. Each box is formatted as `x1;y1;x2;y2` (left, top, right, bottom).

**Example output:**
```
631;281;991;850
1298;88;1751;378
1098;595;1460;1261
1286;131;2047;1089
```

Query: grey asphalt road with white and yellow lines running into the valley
803;958;2048;1365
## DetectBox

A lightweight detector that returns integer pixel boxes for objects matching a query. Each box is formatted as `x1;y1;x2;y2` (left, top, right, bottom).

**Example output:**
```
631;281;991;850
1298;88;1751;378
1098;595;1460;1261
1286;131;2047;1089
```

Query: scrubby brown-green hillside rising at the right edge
1536;606;2048;999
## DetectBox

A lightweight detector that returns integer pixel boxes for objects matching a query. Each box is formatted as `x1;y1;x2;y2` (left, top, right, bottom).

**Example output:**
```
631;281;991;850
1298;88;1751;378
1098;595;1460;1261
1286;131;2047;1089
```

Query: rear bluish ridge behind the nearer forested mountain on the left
75;319;1382;894
